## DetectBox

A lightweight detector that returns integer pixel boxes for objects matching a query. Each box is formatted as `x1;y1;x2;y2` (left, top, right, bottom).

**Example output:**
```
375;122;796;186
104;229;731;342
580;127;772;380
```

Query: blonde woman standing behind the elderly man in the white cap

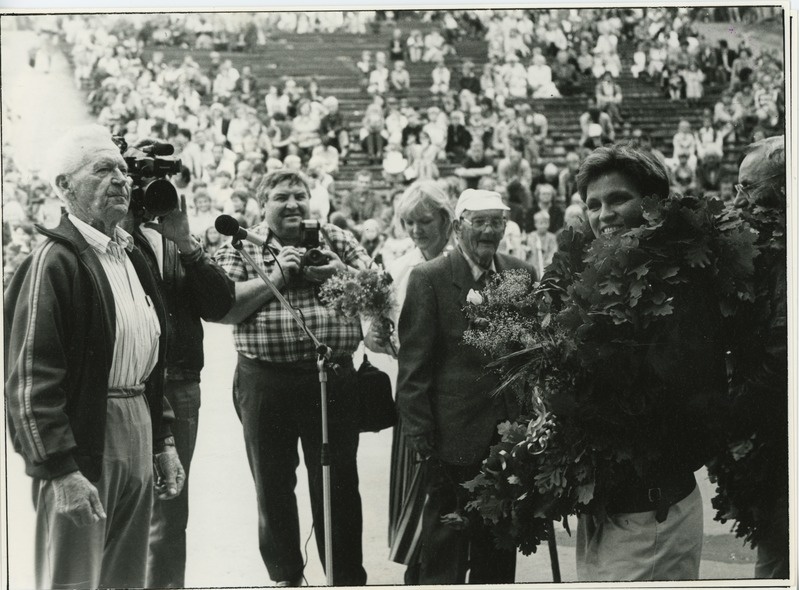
365;180;454;584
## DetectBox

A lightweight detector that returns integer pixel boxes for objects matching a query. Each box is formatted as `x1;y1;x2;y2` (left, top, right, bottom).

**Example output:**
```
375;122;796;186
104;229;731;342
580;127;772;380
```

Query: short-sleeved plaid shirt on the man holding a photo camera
215;223;371;363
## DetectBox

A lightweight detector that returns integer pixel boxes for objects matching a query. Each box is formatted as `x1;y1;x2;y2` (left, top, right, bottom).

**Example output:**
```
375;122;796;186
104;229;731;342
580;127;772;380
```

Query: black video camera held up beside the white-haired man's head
113;136;181;217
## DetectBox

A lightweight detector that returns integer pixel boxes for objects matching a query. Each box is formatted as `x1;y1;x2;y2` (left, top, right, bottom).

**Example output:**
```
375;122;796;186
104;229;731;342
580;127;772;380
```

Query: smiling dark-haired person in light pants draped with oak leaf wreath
564;145;727;581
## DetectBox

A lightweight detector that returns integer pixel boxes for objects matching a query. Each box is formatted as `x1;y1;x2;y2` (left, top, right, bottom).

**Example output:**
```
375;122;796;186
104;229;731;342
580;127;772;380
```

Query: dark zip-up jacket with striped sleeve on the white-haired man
4;215;174;481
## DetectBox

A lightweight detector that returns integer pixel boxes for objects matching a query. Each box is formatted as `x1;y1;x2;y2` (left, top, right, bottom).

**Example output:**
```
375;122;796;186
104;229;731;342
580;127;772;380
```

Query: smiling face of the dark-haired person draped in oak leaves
585;172;643;237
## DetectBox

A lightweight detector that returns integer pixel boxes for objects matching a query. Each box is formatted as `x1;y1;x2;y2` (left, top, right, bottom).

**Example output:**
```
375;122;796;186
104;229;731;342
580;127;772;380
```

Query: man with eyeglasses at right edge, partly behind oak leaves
709;136;790;579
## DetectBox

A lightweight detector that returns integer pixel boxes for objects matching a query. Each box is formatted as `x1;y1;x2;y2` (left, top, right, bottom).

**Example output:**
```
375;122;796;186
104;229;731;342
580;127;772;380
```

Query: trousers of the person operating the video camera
147;380;200;588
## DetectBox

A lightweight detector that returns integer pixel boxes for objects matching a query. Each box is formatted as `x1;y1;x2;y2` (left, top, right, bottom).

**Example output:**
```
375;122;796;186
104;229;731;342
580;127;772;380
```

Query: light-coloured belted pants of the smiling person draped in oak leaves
577;487;703;582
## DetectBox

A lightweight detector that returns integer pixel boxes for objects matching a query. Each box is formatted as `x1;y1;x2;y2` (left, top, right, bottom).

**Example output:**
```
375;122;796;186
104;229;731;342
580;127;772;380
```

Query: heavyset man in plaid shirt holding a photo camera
216;170;370;586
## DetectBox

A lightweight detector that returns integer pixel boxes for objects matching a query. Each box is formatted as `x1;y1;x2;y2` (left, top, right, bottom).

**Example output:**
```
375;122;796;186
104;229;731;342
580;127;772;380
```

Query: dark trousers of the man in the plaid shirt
233;355;366;586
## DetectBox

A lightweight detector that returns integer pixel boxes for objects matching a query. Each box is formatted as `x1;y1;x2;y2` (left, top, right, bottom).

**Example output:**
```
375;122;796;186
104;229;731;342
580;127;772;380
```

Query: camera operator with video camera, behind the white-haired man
115;140;234;588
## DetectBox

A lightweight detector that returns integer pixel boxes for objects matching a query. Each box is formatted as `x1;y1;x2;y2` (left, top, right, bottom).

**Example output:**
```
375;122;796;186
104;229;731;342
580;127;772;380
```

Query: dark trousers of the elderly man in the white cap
418;459;516;584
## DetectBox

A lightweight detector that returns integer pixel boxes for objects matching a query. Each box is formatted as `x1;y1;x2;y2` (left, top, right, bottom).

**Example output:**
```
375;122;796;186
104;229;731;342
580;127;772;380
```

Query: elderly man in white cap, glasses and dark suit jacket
397;189;535;584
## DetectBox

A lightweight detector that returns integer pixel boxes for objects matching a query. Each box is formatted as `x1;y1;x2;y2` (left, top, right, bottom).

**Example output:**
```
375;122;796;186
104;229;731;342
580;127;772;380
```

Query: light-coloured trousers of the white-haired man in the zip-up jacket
34;395;153;588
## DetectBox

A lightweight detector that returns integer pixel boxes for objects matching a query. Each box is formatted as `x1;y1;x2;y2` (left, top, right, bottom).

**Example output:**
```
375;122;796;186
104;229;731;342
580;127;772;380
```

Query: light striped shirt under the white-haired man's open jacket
69;214;161;389
